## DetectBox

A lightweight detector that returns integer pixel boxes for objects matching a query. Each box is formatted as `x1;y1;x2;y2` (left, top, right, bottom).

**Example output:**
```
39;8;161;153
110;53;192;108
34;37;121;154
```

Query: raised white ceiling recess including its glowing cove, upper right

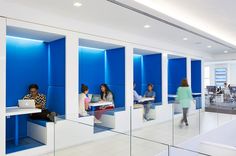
130;0;236;45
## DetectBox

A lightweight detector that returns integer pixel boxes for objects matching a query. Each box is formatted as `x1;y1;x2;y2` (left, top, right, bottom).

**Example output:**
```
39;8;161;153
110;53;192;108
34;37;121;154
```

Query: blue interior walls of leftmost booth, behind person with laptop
6;36;65;143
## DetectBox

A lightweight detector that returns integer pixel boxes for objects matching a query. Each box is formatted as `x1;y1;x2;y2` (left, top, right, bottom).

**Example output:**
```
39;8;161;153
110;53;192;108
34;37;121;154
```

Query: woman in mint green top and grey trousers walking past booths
177;79;193;126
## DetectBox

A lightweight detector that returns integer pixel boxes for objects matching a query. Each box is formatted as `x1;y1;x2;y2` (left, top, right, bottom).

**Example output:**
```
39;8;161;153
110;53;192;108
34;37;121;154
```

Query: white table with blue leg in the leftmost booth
6;106;41;146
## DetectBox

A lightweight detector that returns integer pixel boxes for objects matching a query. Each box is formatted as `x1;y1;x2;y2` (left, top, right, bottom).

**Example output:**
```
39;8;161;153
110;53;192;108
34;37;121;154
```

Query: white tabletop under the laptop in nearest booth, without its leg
6;106;42;116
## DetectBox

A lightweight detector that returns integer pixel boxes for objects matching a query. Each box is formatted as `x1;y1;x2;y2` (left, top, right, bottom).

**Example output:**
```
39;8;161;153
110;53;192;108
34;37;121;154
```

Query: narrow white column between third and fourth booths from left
162;53;168;104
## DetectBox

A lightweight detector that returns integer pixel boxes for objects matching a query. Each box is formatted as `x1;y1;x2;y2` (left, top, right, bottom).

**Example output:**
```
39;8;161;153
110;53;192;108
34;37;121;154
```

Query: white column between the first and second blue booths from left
65;32;79;119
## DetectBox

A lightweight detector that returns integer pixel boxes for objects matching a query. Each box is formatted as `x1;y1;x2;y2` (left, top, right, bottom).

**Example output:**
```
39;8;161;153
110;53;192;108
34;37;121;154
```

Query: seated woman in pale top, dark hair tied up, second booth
79;84;90;116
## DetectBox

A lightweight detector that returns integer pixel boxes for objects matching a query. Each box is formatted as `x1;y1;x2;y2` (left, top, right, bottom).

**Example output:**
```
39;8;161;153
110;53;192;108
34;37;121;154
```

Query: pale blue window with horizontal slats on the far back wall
215;68;227;87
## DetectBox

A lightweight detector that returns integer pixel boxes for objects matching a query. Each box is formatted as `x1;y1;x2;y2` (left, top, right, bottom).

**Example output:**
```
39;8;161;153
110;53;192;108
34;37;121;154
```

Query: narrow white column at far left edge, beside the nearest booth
0;18;6;156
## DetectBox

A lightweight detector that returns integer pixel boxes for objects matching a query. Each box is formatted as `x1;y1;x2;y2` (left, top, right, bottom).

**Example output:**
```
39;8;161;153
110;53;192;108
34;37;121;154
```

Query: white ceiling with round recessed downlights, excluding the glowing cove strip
1;0;236;54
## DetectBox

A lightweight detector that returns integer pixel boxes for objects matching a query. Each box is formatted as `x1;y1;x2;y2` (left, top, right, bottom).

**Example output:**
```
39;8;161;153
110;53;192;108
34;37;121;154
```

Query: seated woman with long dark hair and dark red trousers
95;84;114;123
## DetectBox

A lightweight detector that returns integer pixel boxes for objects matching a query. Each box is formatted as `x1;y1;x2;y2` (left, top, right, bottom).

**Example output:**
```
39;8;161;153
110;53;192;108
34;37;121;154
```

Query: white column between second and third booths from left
125;46;134;110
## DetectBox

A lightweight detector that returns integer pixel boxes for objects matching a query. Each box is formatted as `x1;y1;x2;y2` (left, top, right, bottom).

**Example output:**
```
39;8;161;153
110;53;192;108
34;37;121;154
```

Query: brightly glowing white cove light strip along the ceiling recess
134;0;236;46
